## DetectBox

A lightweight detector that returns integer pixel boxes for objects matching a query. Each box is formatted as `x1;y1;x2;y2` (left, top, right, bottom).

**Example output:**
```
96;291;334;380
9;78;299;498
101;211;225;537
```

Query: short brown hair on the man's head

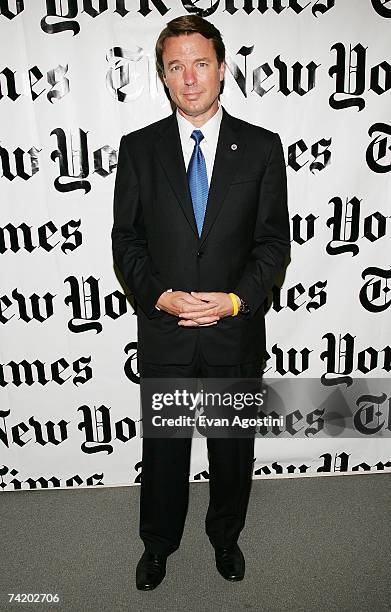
155;15;225;75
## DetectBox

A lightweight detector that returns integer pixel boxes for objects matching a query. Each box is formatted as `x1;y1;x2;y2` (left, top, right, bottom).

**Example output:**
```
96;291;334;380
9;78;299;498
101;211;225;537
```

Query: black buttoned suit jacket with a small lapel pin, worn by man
112;110;290;365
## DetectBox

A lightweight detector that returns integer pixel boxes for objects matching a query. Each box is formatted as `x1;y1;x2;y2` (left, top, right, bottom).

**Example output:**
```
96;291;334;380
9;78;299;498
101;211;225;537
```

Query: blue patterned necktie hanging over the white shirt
187;130;208;236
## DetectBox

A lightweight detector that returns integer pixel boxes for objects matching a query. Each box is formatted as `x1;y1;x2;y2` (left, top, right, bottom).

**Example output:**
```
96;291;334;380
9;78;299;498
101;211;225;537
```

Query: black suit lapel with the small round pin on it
200;109;245;246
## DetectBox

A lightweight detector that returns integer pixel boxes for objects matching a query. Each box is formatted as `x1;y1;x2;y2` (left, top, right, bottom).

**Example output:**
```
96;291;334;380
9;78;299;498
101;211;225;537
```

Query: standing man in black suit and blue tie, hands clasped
112;15;290;590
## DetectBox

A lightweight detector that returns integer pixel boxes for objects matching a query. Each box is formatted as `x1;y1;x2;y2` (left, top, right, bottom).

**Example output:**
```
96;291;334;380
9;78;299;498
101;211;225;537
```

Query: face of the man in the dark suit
163;33;224;121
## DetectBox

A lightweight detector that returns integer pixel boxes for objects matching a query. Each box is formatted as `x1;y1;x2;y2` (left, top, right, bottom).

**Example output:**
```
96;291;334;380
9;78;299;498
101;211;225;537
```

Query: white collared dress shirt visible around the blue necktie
176;103;223;187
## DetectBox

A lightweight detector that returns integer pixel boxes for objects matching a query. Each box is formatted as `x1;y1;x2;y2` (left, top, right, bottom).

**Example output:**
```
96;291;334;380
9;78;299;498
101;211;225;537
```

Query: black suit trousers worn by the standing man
139;338;261;555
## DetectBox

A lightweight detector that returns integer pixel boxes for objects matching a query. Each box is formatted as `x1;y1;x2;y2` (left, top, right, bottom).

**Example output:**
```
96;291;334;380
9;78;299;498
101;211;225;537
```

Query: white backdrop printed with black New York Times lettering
0;0;391;491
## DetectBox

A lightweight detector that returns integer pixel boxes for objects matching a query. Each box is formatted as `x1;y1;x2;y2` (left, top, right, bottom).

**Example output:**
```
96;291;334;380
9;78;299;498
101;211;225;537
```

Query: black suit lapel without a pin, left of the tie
156;114;198;238
